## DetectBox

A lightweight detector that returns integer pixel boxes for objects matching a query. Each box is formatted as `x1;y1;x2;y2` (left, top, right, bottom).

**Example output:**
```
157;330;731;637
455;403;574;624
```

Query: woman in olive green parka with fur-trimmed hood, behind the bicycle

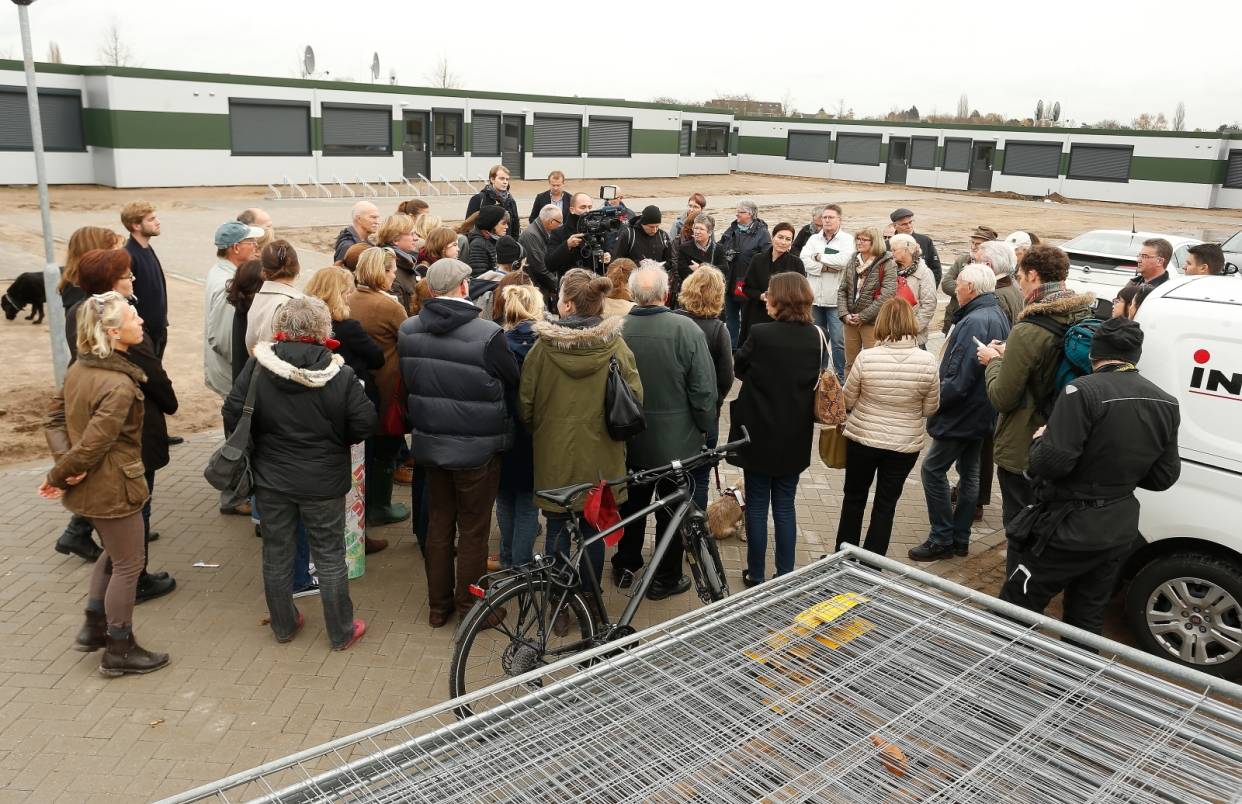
518;268;642;578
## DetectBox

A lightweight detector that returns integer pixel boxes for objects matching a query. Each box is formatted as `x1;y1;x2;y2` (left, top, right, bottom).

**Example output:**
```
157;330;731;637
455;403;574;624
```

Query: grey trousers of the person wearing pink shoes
255;488;354;647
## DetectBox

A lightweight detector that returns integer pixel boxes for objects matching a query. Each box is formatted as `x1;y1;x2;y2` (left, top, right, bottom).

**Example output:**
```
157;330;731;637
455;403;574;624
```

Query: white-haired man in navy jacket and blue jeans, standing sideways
909;263;1010;562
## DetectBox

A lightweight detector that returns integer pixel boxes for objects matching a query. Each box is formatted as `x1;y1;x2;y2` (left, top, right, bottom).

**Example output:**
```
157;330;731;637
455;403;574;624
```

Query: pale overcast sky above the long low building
0;0;1242;129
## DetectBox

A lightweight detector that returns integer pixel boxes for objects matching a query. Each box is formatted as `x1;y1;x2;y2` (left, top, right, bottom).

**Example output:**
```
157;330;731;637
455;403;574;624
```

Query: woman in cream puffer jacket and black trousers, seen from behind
837;298;940;555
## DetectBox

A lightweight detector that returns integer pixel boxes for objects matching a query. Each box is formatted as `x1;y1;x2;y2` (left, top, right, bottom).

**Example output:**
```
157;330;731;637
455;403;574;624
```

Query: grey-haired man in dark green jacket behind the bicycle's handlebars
612;265;717;600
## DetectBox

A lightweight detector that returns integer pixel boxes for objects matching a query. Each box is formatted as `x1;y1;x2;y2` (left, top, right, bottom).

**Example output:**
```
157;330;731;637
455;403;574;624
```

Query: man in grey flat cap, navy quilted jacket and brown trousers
397;258;519;628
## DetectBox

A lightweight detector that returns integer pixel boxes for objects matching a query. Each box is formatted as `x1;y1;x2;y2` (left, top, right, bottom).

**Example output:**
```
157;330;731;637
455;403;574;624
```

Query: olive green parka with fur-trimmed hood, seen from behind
518;317;643;512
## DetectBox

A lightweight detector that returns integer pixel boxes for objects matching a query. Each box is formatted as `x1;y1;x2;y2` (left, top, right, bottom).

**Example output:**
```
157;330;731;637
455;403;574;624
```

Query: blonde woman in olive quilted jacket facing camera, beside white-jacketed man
837;226;897;377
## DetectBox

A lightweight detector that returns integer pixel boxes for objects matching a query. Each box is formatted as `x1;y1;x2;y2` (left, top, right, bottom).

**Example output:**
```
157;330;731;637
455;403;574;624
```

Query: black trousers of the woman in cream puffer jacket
837;439;919;555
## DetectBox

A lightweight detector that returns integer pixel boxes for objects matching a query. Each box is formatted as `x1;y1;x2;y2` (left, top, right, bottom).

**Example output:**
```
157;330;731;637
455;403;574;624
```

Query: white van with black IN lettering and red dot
1123;276;1242;677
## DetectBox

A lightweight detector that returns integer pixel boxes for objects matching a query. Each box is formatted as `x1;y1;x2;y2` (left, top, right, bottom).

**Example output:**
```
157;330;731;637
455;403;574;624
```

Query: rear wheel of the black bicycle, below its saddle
448;578;595;717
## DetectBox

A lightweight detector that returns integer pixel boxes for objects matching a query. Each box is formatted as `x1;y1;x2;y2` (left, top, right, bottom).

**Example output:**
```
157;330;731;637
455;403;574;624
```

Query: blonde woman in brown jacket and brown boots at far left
39;291;168;676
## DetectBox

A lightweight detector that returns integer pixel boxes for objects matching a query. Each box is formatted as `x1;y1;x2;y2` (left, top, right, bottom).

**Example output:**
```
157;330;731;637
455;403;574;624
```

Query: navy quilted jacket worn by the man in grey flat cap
397;298;519;470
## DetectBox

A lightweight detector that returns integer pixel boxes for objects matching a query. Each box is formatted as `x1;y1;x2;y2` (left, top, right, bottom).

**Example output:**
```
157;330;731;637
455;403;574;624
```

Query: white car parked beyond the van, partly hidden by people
1061;229;1203;318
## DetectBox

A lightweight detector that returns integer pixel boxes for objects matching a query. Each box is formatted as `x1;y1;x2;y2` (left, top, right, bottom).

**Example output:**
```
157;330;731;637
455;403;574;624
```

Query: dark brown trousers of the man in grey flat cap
424;455;501;616
